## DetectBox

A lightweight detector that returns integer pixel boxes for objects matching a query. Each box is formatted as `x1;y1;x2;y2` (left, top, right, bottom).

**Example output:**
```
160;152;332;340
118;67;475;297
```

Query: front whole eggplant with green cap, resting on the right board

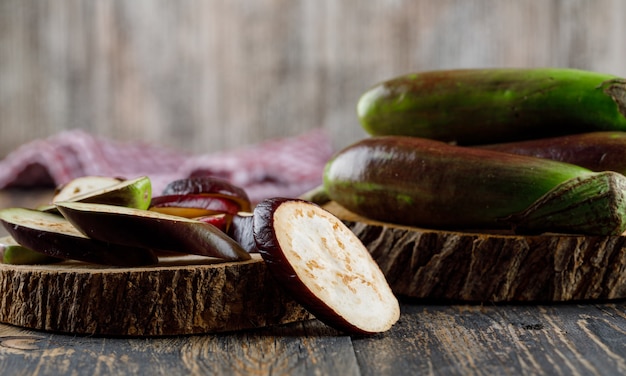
324;136;626;235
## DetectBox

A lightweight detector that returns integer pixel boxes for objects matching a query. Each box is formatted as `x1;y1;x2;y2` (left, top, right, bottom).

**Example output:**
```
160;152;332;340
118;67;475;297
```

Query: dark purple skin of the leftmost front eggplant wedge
2;209;159;267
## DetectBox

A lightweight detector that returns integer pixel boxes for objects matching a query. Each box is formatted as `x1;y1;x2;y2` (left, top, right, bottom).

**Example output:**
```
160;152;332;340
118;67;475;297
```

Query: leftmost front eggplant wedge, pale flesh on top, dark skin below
0;208;158;266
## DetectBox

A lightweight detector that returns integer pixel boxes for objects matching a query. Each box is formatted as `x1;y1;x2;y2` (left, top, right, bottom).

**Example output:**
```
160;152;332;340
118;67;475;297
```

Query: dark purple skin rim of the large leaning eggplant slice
253;197;371;334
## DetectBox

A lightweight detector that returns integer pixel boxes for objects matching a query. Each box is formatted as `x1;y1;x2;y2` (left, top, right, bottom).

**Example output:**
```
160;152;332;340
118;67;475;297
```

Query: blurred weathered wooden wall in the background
0;0;626;157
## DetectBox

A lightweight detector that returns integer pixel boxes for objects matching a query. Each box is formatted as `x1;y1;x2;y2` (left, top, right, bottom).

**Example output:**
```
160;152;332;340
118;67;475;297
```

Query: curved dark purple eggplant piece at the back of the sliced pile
162;176;252;212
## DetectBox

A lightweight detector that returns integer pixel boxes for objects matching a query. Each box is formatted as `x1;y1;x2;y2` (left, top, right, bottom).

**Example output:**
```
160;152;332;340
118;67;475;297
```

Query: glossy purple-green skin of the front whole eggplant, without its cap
324;136;593;229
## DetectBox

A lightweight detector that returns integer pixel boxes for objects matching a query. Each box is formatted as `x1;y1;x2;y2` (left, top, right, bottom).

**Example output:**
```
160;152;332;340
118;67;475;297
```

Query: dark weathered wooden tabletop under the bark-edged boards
0;191;626;375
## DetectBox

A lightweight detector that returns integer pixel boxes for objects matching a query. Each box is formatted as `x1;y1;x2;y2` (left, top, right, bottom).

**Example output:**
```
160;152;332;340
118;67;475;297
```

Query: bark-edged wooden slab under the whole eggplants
325;202;626;302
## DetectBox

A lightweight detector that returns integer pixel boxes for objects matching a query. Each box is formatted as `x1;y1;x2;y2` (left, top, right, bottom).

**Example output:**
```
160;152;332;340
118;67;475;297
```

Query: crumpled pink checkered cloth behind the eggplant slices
0;129;333;202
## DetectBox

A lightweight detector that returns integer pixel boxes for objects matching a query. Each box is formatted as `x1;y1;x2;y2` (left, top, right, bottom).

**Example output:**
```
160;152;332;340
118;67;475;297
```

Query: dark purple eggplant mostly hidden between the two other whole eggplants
478;132;626;174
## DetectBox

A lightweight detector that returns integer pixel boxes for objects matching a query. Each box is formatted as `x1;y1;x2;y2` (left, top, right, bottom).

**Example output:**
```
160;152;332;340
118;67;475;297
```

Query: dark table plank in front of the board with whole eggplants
354;302;626;375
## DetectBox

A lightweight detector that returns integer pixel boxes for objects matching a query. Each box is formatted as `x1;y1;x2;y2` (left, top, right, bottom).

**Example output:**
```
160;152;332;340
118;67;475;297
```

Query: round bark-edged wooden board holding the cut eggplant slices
0;254;312;336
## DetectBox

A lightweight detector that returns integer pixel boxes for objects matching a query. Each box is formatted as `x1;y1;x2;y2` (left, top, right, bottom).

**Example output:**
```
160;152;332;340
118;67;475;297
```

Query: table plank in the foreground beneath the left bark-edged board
0;320;359;376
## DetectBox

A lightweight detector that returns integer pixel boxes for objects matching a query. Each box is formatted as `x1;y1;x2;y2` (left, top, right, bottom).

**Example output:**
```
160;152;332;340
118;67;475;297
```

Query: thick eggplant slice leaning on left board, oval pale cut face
253;198;400;334
